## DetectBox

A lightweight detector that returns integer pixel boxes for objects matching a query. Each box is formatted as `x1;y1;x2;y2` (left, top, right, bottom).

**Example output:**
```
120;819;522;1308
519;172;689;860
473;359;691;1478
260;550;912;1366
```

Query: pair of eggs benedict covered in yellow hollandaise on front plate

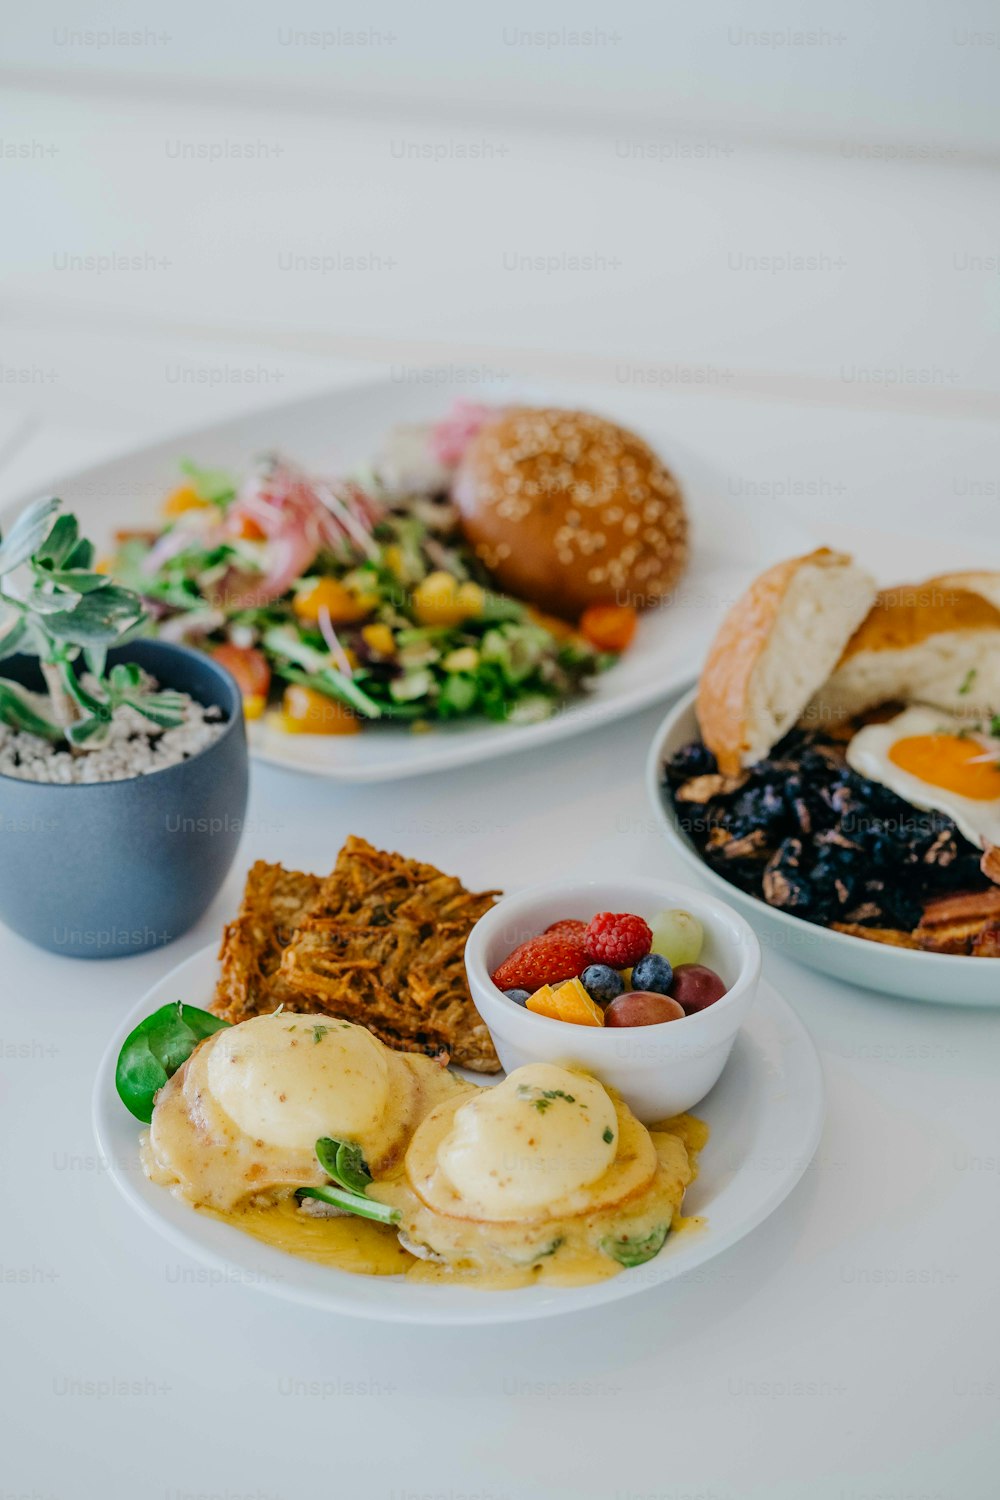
142;1011;705;1287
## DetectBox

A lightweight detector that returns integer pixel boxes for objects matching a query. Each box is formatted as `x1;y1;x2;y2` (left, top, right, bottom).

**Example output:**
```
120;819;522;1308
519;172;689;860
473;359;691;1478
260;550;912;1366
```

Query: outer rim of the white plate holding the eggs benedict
91;944;826;1328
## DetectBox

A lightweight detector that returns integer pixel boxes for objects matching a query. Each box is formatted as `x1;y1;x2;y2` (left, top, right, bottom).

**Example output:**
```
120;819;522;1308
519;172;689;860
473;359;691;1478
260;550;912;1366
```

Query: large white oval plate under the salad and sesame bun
4;371;816;782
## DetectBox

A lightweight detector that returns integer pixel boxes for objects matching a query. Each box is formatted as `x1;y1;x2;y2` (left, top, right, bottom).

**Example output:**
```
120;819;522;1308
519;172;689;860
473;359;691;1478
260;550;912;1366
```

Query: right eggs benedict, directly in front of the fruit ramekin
372;1064;694;1286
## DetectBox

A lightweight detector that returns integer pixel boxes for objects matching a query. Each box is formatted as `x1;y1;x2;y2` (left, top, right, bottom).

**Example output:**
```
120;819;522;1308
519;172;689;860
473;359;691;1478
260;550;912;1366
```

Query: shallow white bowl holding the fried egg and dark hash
646;693;1000;1010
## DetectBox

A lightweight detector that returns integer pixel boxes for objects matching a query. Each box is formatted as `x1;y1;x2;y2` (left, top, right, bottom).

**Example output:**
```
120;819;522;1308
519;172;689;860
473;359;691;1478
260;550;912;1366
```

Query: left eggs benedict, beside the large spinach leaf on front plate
144;1011;469;1211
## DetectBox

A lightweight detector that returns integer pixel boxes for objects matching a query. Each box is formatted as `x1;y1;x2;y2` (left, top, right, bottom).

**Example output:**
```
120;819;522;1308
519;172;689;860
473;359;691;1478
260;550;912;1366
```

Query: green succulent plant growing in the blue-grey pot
0;500;183;753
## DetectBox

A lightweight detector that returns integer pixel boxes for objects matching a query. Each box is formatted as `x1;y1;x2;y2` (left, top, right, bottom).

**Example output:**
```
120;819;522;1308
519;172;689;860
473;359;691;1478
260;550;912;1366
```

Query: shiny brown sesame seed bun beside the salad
451;407;688;620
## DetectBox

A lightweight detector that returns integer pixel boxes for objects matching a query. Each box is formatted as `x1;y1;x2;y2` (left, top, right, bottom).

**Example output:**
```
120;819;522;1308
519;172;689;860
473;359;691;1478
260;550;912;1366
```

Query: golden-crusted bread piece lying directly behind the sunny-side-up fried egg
808;573;1000;722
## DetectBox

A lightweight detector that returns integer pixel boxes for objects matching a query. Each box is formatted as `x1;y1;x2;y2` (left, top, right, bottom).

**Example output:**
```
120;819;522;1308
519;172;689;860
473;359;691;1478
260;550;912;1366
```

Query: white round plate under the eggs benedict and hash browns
93;947;823;1325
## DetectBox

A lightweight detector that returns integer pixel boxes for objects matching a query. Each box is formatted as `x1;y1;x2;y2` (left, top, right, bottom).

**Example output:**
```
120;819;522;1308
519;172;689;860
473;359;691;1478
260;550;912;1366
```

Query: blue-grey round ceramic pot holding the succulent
0;641;247;959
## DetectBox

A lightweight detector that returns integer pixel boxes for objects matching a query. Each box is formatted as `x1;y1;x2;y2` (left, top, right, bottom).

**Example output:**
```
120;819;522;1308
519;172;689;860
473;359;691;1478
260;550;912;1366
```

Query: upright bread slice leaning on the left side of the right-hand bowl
697;548;876;776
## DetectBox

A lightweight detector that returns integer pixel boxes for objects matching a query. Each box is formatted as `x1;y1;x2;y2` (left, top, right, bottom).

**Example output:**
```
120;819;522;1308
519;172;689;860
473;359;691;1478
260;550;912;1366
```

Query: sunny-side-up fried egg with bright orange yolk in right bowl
847;708;1000;848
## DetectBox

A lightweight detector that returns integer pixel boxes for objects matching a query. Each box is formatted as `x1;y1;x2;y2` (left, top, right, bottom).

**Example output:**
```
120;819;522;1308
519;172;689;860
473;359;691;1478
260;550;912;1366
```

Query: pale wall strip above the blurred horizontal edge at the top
3;0;1000;153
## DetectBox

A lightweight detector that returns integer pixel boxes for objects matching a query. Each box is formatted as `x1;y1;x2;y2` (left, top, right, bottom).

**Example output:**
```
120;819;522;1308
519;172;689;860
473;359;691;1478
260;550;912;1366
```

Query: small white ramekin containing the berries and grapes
465;876;760;1122
